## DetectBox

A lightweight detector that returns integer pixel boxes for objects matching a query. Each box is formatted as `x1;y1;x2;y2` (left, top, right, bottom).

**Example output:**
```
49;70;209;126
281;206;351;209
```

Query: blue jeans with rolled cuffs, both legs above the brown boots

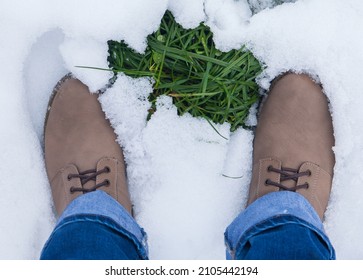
41;191;335;260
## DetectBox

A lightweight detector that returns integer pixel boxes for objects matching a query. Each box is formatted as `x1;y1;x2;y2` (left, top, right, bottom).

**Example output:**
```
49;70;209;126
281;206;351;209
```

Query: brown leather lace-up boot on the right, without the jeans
248;74;335;219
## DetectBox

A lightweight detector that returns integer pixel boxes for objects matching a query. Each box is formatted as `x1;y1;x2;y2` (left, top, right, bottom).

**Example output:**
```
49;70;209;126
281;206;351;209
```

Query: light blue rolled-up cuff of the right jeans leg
225;191;335;259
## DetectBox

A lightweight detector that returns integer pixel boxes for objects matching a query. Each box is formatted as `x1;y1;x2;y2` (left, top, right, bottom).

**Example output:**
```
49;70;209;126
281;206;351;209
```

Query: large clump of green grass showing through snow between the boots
108;11;261;131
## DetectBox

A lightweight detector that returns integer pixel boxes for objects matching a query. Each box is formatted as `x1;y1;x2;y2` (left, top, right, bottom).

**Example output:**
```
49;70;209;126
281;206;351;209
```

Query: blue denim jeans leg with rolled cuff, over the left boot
40;191;148;260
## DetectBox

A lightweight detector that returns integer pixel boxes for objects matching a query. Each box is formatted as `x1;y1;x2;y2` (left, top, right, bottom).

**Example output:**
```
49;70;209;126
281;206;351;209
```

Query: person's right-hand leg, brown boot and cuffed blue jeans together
225;74;335;259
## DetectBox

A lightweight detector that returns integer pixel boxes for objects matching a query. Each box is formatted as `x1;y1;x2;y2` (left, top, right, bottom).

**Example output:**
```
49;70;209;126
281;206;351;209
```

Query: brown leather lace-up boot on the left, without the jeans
44;75;132;214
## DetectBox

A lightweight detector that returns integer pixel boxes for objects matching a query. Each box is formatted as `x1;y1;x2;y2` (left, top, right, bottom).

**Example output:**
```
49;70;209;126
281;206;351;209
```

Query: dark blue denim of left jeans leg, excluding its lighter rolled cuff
40;220;142;260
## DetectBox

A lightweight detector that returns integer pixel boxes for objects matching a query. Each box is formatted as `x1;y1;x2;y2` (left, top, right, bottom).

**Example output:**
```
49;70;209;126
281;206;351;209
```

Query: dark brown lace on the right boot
265;165;311;192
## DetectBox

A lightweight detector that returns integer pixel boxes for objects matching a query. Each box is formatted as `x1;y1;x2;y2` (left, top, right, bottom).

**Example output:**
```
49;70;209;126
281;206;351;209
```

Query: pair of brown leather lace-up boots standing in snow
44;73;335;219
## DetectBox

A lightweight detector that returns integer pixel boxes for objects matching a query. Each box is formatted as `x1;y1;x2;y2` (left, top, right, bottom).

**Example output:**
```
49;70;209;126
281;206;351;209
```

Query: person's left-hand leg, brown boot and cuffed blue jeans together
41;75;148;259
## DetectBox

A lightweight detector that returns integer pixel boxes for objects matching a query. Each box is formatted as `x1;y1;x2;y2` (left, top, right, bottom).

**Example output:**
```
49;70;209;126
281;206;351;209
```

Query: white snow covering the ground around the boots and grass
0;0;363;259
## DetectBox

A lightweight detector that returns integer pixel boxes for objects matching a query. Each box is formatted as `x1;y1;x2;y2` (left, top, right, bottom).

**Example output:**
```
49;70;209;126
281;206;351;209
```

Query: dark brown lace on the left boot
68;166;110;193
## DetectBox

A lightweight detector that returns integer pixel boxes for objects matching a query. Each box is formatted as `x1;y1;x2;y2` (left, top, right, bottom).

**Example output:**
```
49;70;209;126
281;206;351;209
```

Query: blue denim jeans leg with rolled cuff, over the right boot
225;191;335;260
